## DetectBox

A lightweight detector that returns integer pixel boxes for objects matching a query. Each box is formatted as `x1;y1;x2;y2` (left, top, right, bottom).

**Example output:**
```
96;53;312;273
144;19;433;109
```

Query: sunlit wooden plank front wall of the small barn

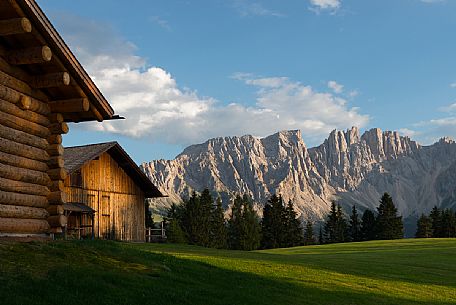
65;153;145;241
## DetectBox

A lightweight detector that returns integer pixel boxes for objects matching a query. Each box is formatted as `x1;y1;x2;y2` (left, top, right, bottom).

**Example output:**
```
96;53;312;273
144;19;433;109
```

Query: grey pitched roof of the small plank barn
63;142;164;198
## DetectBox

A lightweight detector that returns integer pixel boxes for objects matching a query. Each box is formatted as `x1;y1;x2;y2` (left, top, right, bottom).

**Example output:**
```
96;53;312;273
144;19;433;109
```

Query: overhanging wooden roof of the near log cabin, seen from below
0;0;120;122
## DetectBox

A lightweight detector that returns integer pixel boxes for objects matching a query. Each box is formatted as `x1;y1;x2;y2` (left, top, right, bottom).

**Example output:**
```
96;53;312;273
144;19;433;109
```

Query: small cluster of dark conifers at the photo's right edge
415;207;456;238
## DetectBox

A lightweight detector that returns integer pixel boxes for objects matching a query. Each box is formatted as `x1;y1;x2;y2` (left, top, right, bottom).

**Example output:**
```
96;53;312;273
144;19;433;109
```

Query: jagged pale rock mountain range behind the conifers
142;127;456;220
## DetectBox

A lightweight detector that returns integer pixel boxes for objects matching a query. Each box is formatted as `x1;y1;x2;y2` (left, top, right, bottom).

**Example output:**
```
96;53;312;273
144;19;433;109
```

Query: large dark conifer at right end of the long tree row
376;193;404;239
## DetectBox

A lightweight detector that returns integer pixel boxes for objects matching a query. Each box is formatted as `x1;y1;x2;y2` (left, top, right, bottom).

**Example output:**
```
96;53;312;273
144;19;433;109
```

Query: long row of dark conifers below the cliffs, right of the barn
162;189;430;250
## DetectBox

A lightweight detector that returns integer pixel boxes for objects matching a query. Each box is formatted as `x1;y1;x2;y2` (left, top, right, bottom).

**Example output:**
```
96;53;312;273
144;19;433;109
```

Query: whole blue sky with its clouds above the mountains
38;0;456;162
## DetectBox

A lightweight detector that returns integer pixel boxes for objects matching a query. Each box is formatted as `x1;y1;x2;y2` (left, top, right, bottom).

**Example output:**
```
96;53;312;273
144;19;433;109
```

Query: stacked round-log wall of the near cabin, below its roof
0;82;51;236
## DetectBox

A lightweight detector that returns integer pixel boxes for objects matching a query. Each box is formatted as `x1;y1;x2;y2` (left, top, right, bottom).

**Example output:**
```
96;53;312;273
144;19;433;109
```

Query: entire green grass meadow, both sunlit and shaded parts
0;239;456;305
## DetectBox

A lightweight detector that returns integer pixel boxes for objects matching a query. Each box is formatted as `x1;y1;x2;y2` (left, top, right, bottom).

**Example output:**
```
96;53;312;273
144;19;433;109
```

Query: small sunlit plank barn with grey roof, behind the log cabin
63;142;163;241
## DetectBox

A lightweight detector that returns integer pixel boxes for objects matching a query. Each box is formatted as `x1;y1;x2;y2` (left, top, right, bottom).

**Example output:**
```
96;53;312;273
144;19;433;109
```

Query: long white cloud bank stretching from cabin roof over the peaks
53;13;369;145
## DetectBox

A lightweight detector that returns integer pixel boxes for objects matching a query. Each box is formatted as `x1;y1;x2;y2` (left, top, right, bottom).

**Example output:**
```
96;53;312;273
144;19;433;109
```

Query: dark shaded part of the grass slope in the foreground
0;242;451;305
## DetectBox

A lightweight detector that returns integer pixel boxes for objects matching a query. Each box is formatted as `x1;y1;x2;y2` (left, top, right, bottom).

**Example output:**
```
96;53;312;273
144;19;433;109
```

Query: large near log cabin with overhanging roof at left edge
0;0;120;238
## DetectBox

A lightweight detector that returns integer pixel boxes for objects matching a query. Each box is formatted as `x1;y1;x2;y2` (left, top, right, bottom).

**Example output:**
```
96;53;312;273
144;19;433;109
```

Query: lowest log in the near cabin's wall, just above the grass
0;218;50;234
